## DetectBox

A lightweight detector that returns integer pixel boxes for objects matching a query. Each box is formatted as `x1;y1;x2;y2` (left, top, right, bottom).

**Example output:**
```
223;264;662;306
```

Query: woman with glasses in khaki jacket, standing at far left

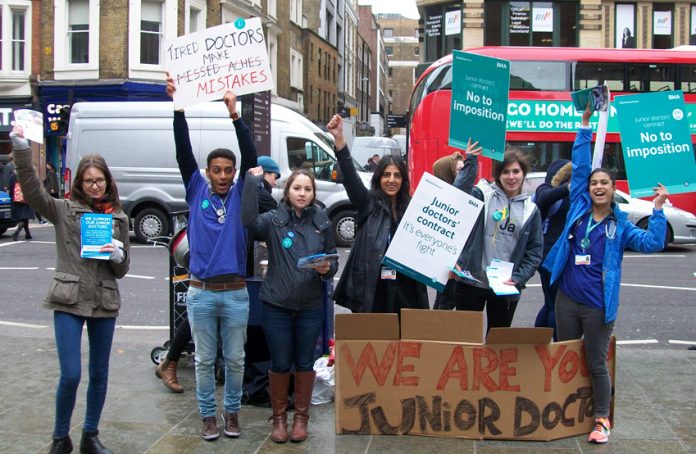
10;126;130;454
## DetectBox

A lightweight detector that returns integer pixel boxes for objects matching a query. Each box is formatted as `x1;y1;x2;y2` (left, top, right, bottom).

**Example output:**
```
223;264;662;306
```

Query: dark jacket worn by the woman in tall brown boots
242;175;338;310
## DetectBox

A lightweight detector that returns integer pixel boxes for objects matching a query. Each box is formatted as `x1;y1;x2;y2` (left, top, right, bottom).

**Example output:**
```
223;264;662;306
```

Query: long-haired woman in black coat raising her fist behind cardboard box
327;115;430;314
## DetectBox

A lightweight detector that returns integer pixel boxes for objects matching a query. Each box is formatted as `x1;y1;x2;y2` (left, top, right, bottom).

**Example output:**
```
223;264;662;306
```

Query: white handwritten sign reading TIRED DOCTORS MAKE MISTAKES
165;17;273;109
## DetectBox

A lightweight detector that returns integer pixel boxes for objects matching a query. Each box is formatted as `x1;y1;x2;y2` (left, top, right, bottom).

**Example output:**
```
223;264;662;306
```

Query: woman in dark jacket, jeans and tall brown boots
242;167;338;443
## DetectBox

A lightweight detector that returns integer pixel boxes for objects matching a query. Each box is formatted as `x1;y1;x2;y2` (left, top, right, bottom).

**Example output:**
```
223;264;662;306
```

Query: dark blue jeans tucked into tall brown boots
261;303;324;374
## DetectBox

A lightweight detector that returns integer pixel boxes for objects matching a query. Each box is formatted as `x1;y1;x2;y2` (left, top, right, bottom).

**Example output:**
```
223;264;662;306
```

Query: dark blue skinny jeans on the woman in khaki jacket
53;311;116;438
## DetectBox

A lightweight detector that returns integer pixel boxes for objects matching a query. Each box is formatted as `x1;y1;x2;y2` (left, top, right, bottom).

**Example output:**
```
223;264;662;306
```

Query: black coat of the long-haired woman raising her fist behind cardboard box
332;146;430;312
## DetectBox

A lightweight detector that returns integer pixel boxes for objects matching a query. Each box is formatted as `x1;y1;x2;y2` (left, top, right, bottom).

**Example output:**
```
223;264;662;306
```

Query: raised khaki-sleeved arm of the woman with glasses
10;126;58;224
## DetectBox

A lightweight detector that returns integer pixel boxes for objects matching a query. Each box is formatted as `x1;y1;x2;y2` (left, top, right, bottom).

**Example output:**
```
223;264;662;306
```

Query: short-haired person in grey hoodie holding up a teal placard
454;145;543;330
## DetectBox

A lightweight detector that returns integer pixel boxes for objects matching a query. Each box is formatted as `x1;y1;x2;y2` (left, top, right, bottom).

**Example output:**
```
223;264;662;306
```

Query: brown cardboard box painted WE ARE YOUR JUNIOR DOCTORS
336;310;615;440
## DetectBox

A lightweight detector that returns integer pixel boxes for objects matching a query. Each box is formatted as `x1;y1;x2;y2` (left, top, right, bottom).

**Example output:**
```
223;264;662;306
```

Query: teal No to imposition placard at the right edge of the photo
614;90;696;197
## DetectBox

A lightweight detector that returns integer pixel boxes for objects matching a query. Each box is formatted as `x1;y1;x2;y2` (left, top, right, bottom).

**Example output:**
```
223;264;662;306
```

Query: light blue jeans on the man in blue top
186;287;249;418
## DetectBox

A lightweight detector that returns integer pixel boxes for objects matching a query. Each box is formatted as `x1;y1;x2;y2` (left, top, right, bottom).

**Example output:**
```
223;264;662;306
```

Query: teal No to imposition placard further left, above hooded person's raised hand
449;50;510;161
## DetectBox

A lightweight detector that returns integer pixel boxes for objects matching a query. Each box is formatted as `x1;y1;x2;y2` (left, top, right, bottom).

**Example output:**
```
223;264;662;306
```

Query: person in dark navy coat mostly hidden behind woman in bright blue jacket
534;159;572;339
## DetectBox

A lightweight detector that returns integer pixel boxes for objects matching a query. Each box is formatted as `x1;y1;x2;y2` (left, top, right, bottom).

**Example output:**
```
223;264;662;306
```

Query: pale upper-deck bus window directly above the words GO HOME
510;61;570;91
